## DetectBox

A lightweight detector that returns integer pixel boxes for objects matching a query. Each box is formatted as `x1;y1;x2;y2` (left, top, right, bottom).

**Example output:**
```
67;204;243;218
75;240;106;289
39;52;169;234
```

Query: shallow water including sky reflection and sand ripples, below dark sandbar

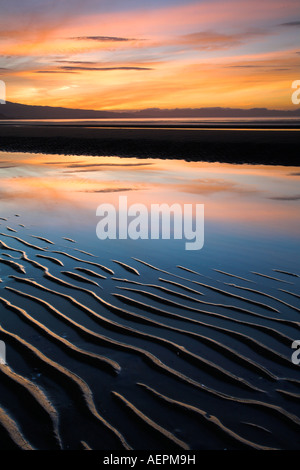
0;152;300;449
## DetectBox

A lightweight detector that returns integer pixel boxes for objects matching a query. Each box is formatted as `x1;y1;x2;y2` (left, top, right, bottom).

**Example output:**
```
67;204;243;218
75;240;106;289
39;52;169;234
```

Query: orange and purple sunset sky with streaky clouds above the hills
0;0;300;110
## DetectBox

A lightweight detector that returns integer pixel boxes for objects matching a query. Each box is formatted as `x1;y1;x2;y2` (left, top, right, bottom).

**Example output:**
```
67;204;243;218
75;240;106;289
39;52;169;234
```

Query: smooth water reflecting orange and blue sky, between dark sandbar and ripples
0;153;300;271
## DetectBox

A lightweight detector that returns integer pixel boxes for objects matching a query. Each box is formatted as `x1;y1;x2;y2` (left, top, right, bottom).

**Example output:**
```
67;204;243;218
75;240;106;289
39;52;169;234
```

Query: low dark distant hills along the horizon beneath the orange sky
0;101;300;120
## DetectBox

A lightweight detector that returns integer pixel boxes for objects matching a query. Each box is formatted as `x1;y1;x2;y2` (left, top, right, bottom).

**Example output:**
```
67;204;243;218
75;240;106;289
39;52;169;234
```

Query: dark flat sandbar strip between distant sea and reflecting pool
0;124;300;166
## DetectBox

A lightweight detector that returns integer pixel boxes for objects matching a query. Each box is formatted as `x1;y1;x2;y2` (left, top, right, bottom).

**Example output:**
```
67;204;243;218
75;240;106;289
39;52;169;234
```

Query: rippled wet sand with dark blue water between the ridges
0;218;300;451
